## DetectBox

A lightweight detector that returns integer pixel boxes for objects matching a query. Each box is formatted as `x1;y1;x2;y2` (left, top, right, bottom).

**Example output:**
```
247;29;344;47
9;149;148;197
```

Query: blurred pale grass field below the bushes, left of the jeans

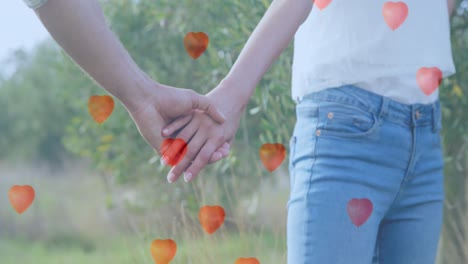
0;163;287;264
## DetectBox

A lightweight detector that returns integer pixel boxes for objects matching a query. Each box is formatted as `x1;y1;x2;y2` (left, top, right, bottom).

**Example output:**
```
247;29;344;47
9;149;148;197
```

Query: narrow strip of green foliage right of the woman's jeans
439;1;468;263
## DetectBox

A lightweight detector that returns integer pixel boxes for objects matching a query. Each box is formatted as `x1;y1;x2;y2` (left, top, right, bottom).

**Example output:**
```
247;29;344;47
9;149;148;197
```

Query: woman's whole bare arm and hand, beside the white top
163;0;312;182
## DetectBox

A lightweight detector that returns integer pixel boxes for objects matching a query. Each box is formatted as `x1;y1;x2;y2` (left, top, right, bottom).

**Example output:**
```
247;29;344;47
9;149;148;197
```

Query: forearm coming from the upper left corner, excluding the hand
36;0;150;112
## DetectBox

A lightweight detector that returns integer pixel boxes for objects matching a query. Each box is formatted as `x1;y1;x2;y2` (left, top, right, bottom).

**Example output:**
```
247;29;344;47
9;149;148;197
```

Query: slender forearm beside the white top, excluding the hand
221;0;313;106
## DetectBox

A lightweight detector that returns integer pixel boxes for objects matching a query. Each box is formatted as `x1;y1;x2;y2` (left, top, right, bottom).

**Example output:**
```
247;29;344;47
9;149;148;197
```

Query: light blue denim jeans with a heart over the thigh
287;85;444;264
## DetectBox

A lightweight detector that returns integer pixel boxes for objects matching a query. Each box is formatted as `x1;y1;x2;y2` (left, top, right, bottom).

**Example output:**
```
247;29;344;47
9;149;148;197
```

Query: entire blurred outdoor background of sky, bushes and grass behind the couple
0;0;468;264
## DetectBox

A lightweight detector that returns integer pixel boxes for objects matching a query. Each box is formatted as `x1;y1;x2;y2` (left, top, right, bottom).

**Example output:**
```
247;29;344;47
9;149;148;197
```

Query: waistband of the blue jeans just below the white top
298;85;441;131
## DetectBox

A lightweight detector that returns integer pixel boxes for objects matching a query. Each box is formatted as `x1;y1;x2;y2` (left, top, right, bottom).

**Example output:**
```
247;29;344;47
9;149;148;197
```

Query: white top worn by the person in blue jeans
292;0;455;104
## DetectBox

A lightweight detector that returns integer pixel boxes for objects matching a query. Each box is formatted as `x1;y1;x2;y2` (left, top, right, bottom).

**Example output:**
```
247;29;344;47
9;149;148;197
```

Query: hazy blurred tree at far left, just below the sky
0;42;73;166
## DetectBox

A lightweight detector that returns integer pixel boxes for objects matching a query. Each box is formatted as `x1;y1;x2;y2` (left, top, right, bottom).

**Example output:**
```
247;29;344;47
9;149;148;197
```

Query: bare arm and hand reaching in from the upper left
24;0;229;159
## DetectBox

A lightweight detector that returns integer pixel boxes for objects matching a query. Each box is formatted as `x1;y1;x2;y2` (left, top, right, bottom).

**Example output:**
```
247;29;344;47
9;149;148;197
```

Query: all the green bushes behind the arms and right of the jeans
0;0;468;263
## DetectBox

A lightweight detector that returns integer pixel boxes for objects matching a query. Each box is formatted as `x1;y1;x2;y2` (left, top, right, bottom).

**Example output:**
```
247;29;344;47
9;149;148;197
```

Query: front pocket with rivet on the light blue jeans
317;101;379;138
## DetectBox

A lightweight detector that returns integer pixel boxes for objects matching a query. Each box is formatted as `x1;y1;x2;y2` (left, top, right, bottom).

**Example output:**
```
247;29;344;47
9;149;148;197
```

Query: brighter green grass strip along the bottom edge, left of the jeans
0;232;286;264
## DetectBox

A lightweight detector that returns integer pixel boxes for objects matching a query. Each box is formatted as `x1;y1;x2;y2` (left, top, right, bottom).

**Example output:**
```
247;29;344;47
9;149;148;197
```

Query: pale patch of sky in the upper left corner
0;0;49;67
